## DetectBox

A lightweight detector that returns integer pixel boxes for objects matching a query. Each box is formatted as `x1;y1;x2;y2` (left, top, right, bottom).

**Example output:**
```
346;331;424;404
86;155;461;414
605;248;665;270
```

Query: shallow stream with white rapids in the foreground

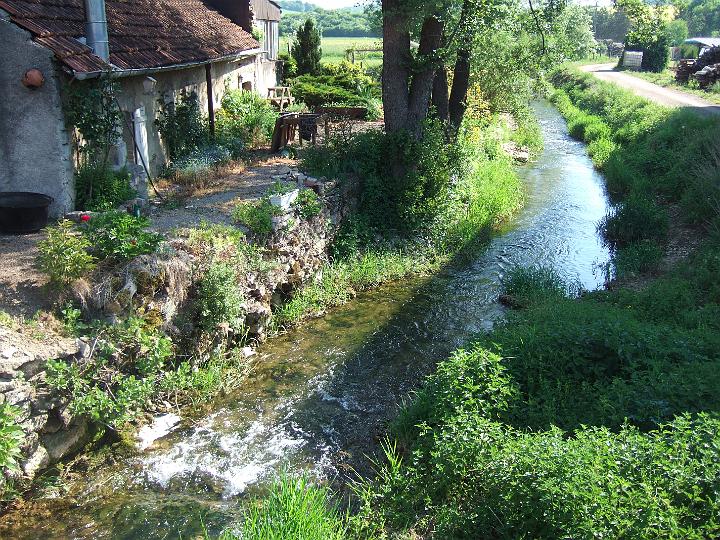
4;102;608;539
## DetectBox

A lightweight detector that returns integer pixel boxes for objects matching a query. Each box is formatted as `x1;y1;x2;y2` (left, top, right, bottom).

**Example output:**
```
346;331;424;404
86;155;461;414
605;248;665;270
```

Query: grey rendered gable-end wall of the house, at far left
0;10;74;216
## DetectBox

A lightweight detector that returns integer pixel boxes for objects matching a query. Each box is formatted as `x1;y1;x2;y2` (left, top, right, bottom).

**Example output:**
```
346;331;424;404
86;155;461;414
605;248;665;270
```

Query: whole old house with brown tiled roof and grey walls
0;0;280;216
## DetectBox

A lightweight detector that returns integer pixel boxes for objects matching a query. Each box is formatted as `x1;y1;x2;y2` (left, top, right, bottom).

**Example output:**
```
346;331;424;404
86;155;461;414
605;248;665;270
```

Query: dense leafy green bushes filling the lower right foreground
357;244;720;538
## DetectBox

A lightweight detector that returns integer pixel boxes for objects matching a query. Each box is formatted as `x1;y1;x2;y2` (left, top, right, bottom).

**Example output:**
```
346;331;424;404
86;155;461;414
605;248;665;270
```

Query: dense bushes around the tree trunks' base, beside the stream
304;116;522;250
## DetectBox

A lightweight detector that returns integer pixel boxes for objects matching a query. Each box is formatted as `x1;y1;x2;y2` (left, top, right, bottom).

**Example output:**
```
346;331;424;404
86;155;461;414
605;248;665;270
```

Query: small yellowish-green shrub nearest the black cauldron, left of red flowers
37;220;95;287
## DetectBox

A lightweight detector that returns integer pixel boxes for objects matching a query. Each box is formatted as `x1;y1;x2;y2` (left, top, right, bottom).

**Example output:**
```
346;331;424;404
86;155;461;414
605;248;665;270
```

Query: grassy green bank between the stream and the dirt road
550;64;720;278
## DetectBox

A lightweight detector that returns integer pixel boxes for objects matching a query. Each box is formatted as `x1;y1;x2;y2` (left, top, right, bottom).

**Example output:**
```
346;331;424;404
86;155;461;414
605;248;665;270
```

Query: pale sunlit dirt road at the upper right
580;64;720;114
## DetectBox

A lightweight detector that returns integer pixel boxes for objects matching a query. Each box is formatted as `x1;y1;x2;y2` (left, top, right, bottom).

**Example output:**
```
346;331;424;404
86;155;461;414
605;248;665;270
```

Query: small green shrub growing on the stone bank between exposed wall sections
198;262;244;335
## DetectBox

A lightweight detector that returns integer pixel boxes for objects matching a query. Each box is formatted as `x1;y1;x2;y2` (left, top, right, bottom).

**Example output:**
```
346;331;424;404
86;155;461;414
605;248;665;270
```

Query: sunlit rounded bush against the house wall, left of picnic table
215;90;278;146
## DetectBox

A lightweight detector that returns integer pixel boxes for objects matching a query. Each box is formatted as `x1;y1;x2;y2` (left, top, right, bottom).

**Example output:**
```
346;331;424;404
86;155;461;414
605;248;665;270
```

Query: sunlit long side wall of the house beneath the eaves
116;55;276;174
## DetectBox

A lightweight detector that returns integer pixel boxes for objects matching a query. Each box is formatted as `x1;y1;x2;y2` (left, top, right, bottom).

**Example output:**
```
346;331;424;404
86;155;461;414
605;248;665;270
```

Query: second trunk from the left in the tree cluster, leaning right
408;15;443;138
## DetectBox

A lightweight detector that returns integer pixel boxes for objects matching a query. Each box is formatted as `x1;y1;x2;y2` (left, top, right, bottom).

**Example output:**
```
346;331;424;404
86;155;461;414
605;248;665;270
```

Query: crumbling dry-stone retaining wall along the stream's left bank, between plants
0;174;356;490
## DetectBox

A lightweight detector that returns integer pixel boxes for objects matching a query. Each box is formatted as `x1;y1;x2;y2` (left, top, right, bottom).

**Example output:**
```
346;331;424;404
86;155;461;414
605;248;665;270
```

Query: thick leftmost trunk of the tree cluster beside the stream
382;0;411;133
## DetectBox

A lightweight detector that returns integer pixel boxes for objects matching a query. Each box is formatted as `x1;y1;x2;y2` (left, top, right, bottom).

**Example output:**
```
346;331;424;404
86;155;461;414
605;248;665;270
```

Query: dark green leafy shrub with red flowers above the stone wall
83;210;162;261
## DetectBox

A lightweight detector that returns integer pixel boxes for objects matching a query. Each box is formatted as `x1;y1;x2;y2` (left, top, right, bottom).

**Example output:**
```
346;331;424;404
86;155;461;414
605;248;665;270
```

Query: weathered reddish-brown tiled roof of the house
0;0;260;72
